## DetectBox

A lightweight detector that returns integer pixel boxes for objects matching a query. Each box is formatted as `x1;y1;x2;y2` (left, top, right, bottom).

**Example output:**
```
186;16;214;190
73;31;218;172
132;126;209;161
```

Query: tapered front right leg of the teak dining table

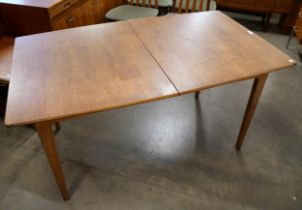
235;74;268;150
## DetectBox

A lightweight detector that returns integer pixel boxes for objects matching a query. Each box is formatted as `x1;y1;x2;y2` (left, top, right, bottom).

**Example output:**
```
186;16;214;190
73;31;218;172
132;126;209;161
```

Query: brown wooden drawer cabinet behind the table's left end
0;0;124;37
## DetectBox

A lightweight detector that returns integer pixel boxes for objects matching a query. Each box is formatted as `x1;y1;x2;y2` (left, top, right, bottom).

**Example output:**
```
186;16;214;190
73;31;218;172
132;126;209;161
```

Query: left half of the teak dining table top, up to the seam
5;22;178;125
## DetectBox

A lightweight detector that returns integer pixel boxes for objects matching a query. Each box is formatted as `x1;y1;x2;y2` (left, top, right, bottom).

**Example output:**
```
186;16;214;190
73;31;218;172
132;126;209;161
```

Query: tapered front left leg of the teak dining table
35;122;70;201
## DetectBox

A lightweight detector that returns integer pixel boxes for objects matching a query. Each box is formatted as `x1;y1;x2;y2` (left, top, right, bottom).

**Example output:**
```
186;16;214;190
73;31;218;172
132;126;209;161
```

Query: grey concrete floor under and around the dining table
0;11;302;210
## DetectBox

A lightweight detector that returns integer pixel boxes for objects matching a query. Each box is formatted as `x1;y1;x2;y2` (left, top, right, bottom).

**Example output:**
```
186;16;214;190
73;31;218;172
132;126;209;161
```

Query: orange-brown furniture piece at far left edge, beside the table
0;37;14;84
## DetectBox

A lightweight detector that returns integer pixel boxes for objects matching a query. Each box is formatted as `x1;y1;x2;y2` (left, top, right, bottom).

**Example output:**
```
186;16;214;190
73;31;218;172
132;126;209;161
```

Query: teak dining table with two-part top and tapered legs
5;11;296;200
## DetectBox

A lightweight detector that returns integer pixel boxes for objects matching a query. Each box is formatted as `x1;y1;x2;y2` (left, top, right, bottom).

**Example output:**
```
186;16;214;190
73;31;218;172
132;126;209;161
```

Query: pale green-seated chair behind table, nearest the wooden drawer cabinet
105;0;159;21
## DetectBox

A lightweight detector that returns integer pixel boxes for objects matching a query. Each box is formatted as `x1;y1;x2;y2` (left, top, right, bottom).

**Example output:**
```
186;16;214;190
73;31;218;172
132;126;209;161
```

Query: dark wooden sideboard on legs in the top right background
216;0;302;33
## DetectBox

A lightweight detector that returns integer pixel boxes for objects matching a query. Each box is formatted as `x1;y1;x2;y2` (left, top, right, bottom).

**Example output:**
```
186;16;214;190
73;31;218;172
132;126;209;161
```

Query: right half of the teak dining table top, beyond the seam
130;11;295;94
